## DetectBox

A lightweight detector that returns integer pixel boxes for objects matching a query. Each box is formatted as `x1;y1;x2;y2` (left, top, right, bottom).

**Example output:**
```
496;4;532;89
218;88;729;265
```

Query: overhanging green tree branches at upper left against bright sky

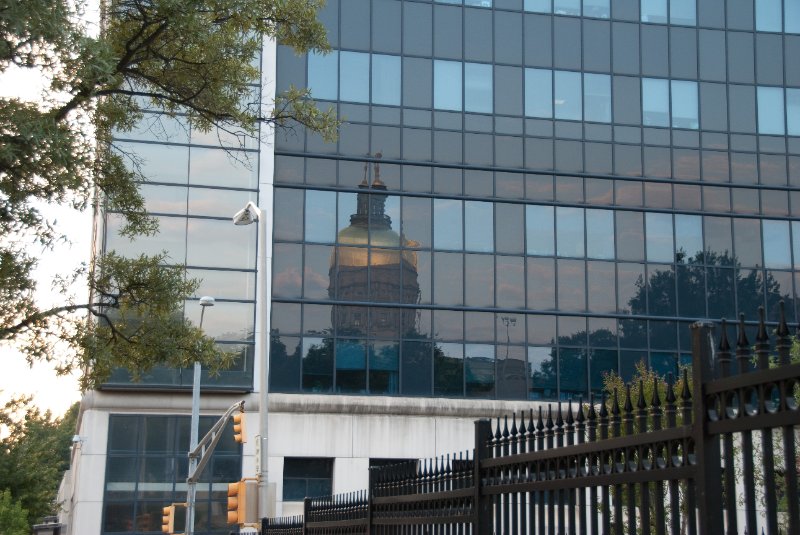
0;0;338;387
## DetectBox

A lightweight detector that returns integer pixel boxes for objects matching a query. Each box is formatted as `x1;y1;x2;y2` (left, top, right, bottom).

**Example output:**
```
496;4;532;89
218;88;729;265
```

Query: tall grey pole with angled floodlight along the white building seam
233;201;270;518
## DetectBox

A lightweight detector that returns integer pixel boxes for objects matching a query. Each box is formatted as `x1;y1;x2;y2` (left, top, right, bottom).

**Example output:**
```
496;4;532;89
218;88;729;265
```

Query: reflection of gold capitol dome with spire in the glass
328;153;420;337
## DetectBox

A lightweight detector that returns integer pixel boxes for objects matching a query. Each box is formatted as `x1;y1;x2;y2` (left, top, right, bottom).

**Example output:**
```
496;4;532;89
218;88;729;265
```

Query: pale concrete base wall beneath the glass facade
62;392;537;535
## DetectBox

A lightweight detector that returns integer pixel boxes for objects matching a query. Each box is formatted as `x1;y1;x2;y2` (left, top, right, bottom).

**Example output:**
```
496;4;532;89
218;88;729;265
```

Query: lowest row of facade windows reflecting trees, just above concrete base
270;338;689;399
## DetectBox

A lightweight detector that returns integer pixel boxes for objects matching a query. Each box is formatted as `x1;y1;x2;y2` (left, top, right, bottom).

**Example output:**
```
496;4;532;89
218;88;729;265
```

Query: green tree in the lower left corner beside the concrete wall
0;397;78;533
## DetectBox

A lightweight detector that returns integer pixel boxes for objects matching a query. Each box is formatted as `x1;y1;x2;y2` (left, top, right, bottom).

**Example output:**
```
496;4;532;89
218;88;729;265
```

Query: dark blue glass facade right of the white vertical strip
270;0;800;400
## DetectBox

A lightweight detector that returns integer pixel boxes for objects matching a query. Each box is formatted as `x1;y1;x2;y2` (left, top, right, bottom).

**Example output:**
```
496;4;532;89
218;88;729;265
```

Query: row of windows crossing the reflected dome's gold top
273;189;800;269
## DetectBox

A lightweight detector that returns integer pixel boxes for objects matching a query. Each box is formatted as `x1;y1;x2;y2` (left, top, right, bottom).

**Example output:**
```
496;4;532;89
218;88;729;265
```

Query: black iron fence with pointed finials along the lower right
263;310;800;535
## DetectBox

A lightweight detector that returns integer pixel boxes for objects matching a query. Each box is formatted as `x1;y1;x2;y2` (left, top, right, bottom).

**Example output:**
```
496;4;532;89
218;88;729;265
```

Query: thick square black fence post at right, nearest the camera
684;322;724;535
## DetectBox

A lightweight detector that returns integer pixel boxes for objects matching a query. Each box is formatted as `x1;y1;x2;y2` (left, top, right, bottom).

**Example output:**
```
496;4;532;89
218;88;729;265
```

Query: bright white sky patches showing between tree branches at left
0;69;91;415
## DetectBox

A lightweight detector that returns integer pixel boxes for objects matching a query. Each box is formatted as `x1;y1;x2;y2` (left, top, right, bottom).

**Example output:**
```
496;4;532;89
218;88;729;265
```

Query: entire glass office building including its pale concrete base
65;0;800;535
